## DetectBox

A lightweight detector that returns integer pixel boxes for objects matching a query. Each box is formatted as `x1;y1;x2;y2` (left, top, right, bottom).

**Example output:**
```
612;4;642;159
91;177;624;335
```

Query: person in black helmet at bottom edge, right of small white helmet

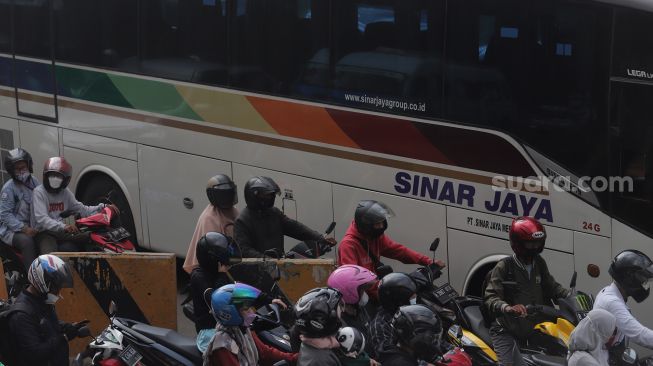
379;305;472;366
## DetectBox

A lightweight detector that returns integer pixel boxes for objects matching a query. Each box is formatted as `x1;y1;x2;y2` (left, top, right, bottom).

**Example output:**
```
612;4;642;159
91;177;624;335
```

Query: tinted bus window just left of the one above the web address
229;0;329;97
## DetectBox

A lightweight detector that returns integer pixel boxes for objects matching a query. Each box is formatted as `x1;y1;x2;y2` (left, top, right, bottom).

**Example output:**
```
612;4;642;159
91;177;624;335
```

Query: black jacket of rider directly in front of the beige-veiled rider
190;267;232;333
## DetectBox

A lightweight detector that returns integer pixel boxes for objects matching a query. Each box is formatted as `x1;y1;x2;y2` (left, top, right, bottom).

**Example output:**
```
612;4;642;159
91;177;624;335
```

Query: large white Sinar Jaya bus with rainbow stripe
0;0;653;325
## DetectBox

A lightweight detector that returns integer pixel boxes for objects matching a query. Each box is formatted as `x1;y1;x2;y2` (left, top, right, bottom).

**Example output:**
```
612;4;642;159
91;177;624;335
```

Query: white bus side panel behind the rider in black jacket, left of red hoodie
232;164;338;258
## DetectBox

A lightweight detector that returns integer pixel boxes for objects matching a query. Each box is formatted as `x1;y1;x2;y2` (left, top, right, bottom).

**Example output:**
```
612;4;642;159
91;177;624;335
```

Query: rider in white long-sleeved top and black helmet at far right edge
594;250;653;361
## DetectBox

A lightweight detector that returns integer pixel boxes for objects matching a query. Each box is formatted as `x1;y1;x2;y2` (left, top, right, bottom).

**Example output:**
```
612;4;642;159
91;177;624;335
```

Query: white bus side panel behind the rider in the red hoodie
333;185;446;281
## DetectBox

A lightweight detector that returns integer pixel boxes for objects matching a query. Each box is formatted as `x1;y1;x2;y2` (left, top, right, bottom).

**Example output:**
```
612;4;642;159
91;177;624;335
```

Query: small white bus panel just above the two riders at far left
20;121;59;170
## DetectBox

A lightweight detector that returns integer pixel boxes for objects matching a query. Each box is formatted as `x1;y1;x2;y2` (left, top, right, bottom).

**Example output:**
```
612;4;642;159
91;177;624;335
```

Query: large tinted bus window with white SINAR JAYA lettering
445;0;610;183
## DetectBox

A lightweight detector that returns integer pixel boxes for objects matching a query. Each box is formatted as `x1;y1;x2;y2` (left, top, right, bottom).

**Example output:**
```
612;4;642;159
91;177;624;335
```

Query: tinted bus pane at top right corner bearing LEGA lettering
612;9;653;80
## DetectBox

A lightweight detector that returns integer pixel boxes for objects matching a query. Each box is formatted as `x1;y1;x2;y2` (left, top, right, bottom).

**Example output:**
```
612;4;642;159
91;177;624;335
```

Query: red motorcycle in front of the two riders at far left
59;207;136;253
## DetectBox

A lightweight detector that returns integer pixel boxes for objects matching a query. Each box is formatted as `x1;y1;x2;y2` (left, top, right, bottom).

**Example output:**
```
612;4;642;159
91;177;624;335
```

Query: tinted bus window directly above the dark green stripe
55;0;137;71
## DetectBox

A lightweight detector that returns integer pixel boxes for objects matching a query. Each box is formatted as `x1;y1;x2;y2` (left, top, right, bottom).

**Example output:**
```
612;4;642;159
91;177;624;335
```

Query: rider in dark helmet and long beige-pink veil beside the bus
184;174;238;274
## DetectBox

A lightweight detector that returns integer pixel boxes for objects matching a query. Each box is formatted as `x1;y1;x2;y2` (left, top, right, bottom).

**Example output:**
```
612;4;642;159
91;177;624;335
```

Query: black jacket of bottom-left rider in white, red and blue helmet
9;291;69;366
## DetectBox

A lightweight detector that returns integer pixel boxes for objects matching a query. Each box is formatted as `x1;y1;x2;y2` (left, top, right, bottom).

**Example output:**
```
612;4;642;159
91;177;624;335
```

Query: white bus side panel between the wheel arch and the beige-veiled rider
138;145;231;257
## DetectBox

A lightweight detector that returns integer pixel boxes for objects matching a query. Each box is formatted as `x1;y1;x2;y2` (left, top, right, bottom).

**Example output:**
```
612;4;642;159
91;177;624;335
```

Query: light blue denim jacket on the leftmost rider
0;176;40;245
